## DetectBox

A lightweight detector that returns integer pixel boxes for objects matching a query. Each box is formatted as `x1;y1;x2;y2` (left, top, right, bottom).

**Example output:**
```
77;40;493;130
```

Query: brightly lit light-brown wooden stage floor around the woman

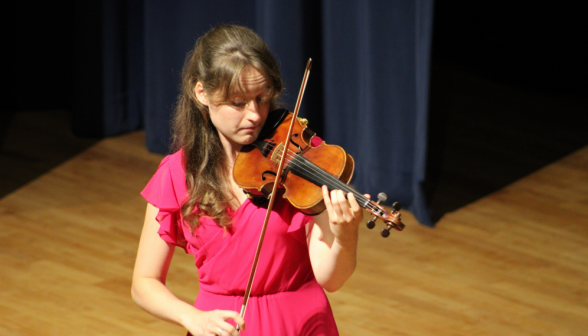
0;132;588;336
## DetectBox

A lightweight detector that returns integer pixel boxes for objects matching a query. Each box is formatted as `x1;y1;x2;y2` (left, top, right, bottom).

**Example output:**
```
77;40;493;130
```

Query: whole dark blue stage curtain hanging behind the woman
74;0;433;226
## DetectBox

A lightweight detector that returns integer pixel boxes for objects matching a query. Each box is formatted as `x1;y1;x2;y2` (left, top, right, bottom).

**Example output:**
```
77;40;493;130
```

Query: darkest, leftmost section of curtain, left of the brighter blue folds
72;0;145;137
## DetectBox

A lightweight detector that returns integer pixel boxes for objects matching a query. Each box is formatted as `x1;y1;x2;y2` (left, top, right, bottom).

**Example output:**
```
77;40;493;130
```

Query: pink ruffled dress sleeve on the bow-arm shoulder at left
141;152;187;250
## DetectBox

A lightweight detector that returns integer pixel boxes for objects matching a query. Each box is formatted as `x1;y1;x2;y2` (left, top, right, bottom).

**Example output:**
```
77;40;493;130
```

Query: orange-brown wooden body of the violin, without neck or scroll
234;110;355;215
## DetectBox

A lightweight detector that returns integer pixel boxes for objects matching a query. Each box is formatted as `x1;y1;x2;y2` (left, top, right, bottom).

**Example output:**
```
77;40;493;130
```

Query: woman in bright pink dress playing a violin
132;26;363;336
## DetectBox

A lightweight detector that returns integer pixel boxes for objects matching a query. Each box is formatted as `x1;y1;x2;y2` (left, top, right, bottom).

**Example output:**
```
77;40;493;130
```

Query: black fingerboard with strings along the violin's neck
288;154;370;209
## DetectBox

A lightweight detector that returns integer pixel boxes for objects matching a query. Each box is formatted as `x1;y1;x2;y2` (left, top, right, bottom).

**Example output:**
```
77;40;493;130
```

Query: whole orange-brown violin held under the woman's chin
233;109;404;237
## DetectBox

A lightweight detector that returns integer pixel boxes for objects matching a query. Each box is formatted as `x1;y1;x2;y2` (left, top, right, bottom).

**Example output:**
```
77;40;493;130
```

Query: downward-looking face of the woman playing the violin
194;67;270;151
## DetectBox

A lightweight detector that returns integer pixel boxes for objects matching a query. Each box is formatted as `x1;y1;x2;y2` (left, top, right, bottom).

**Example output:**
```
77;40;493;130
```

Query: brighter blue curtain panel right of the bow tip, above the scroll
323;0;433;225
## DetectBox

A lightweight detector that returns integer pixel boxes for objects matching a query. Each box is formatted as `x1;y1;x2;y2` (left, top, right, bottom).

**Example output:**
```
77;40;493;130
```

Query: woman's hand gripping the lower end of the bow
181;309;245;336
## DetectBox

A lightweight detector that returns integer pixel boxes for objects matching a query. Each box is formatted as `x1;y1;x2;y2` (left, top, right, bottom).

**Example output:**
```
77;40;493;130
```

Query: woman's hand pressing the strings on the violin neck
323;186;369;245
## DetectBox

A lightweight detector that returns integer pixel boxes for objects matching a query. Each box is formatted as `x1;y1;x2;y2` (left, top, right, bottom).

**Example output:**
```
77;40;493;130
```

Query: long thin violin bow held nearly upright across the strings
237;58;312;330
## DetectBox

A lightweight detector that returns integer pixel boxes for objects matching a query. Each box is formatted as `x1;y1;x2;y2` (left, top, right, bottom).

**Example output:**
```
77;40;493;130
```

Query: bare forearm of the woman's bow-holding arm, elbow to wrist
131;278;202;326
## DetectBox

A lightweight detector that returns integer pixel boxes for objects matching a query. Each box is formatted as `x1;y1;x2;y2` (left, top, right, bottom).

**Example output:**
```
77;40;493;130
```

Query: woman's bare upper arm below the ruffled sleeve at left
133;203;174;283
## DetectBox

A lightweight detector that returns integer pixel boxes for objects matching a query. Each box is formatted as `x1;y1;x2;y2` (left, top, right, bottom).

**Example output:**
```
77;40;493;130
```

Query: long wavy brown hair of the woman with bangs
172;25;282;229
